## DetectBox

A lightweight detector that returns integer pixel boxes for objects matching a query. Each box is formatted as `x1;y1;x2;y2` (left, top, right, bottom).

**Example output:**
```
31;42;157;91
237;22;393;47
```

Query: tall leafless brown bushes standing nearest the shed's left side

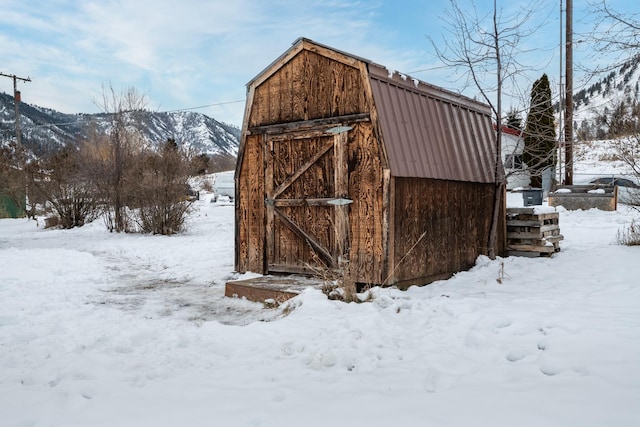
79;87;193;234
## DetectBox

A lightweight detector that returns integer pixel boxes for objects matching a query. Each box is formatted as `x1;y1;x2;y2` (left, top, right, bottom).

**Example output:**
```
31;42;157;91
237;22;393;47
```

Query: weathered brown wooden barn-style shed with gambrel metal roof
235;38;505;288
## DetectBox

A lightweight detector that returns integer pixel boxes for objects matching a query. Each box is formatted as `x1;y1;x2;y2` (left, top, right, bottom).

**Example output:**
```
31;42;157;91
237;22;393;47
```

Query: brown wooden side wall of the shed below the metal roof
389;178;504;287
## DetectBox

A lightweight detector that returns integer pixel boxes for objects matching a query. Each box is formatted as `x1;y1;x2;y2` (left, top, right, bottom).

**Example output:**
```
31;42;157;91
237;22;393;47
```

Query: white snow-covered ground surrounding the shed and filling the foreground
0;189;640;427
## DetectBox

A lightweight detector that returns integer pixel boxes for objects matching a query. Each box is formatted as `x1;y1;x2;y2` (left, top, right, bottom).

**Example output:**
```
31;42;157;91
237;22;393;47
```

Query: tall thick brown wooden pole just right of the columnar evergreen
564;0;573;185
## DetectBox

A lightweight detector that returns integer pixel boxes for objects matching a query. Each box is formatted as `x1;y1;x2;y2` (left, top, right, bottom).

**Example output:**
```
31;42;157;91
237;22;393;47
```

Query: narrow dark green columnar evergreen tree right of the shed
523;74;556;187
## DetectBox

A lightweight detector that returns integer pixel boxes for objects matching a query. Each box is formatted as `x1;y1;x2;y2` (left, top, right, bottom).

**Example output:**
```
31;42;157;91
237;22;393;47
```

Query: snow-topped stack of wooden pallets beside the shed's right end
507;208;564;257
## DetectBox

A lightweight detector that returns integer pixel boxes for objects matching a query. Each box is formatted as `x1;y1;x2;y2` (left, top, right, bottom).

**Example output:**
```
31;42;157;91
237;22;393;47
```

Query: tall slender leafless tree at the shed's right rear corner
431;0;535;258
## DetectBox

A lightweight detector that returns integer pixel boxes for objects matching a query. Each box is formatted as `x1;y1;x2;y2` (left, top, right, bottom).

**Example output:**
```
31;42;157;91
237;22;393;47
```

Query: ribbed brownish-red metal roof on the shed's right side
368;63;496;183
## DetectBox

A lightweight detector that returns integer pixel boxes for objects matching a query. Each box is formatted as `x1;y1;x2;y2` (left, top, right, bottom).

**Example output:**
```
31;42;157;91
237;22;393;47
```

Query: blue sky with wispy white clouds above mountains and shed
0;0;634;126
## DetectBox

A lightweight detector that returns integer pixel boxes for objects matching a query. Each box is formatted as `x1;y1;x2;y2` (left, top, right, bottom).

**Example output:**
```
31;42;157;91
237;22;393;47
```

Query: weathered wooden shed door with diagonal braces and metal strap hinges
264;127;351;273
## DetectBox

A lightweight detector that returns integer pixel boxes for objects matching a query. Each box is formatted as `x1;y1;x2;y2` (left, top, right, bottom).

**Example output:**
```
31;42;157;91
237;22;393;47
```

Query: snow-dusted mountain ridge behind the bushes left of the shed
0;93;240;157
